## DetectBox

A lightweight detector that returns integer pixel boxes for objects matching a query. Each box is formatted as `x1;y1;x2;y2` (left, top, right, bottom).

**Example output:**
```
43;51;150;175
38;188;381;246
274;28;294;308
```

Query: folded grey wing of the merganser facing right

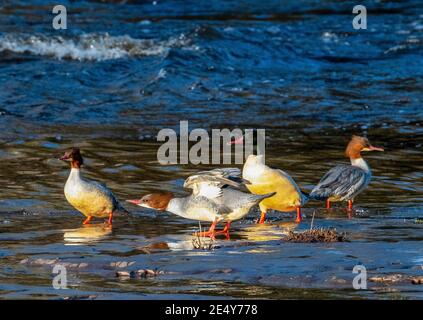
310;165;367;200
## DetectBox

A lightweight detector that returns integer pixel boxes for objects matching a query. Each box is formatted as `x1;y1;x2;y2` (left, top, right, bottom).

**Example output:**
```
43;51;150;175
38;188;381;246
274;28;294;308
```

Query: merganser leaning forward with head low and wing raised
127;168;274;238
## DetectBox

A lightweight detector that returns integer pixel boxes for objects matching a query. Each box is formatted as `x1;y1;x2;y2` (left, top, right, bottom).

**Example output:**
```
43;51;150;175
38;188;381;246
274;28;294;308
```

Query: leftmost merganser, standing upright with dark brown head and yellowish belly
60;148;126;225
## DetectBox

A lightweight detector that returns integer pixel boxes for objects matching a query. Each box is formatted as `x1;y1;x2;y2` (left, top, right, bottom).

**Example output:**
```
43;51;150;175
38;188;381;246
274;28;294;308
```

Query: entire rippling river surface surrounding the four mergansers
0;0;423;299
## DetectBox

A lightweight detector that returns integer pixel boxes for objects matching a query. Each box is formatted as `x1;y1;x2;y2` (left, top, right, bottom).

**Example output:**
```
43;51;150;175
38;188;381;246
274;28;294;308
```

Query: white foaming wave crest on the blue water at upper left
0;34;195;61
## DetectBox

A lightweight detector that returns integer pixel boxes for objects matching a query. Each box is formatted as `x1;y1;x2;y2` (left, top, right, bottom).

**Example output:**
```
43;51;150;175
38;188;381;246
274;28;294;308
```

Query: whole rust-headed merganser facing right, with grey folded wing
310;135;384;211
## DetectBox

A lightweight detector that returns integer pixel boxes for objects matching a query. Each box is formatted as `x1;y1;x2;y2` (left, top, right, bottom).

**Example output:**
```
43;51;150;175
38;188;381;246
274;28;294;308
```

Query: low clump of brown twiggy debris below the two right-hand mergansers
283;228;348;243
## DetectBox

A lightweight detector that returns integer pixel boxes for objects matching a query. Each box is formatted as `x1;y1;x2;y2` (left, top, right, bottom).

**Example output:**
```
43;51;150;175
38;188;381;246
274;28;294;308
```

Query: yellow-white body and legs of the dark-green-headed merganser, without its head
242;155;308;223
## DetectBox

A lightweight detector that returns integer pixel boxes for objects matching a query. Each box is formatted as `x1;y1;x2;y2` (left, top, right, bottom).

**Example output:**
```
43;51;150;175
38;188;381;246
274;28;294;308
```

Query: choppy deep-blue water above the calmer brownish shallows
0;1;423;136
